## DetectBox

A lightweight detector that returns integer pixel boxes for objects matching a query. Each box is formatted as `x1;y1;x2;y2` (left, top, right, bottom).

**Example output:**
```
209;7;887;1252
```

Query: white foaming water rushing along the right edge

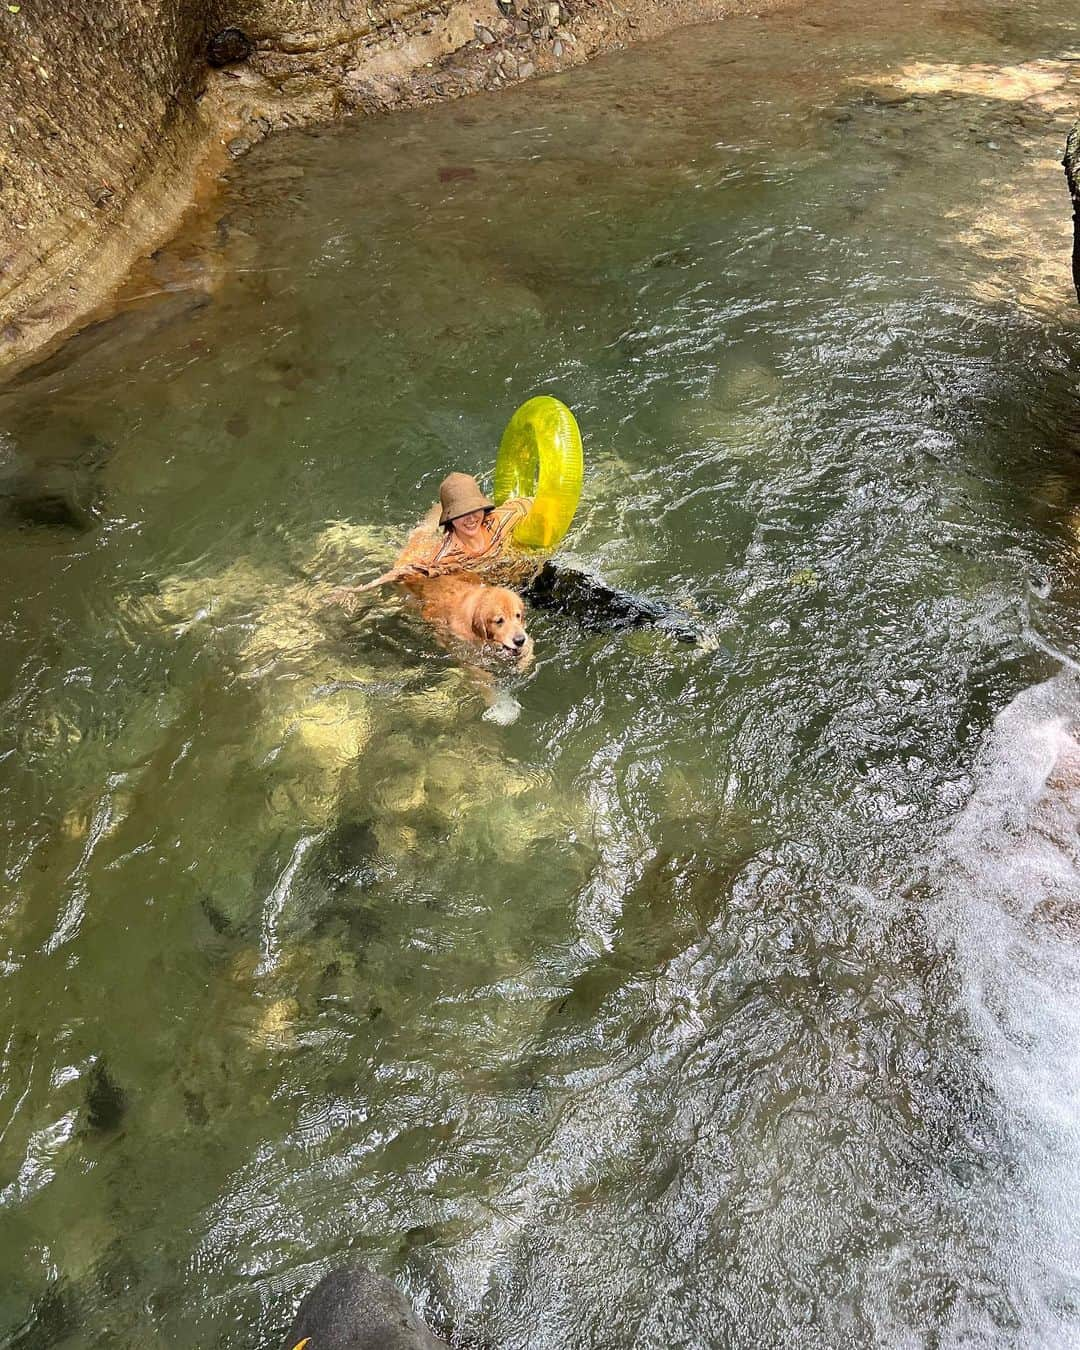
942;674;1080;1346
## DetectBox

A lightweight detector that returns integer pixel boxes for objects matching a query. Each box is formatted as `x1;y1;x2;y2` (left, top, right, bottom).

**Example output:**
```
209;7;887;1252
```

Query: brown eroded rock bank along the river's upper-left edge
0;0;798;373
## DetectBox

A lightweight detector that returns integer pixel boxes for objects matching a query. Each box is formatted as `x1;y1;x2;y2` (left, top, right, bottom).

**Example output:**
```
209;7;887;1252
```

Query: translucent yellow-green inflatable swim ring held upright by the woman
494;394;585;549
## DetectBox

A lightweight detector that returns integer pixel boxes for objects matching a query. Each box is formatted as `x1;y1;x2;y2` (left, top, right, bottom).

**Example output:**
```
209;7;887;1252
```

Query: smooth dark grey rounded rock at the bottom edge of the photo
285;1266;447;1350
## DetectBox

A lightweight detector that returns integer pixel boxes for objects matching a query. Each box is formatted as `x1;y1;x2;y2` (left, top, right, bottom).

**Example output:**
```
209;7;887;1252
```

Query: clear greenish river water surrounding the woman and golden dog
0;0;1080;1350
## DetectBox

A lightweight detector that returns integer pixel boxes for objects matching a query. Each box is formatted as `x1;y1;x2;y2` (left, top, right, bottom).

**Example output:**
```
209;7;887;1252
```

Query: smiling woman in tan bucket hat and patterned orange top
352;474;532;591
